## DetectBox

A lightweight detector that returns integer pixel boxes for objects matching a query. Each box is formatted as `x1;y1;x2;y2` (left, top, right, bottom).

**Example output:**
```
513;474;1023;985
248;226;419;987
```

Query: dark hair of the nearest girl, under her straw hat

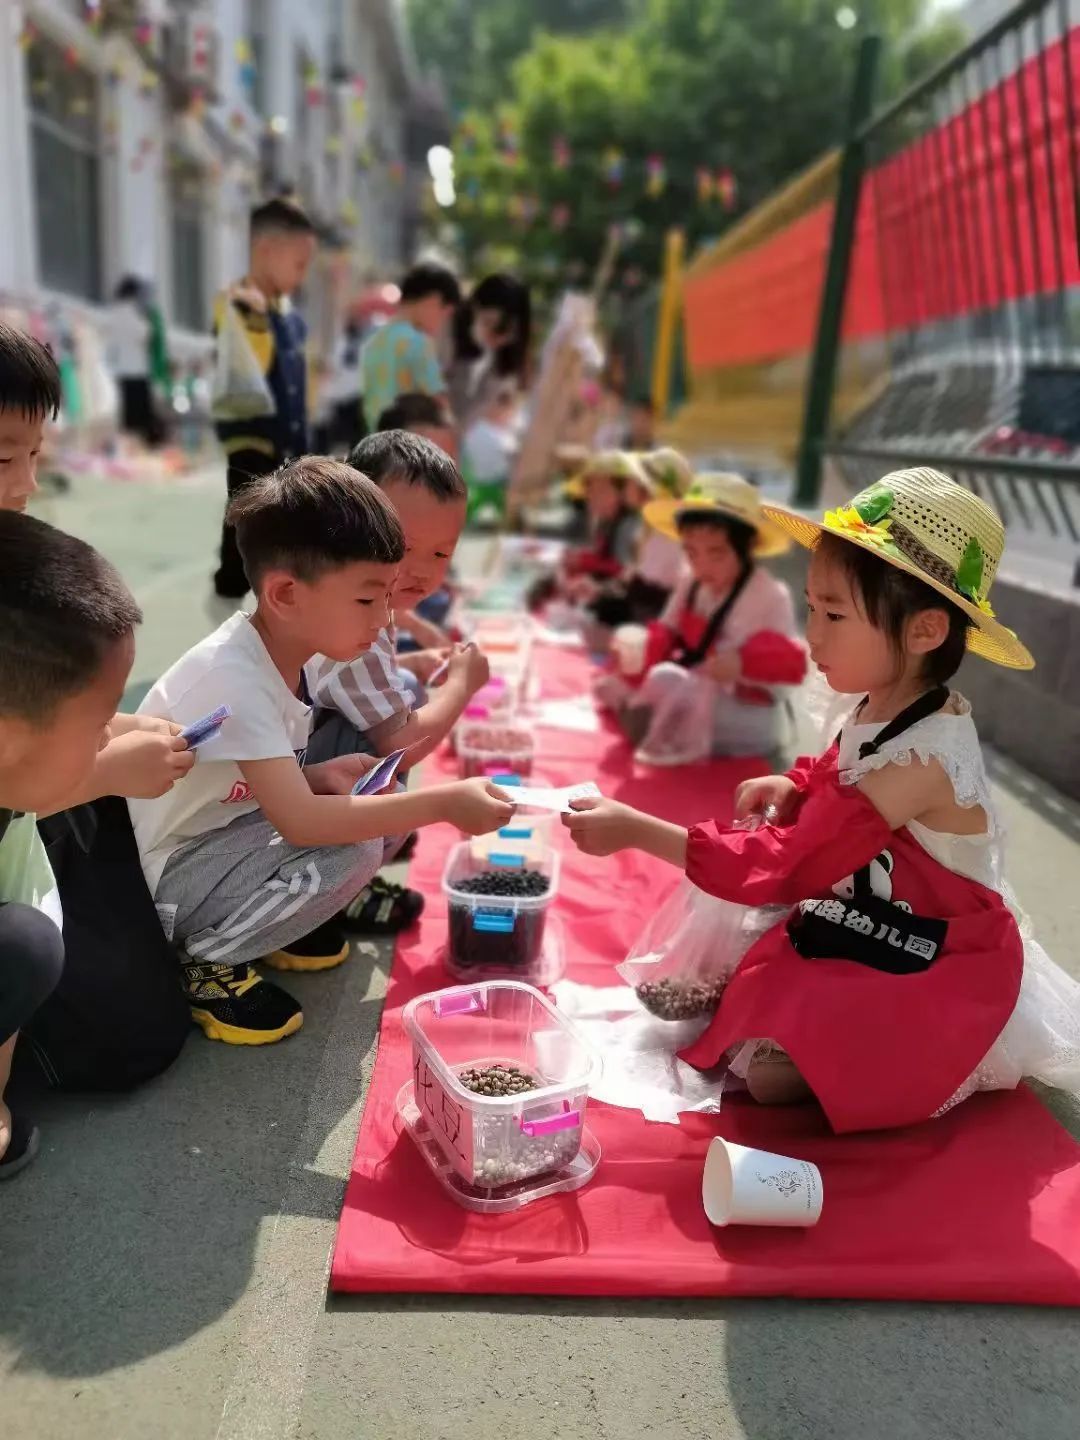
815;534;971;685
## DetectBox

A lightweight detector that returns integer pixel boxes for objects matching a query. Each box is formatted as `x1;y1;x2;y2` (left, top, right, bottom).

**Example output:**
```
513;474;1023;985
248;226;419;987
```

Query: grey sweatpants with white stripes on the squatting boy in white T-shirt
154;811;385;965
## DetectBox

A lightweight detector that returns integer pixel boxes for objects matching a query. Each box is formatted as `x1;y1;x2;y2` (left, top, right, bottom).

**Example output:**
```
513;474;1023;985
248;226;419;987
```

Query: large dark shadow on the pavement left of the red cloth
0;955;384;1376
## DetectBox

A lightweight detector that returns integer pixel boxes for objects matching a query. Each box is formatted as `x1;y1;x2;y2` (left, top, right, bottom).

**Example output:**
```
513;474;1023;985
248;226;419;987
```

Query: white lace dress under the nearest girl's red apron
840;694;1080;1115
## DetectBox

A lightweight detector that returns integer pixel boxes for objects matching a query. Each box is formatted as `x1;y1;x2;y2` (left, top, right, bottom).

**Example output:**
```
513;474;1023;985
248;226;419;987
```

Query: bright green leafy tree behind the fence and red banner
440;0;958;295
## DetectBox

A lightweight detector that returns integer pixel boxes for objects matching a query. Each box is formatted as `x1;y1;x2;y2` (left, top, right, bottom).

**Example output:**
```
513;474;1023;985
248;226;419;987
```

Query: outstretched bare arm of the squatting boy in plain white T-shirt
239;756;514;850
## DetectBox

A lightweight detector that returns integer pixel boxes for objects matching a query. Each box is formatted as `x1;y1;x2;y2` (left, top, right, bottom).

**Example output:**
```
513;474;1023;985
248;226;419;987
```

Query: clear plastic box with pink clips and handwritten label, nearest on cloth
402;981;600;1208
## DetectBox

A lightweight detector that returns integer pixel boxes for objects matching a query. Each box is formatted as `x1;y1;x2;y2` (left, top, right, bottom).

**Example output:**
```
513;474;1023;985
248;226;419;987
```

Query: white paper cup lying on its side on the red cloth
701;1136;824;1225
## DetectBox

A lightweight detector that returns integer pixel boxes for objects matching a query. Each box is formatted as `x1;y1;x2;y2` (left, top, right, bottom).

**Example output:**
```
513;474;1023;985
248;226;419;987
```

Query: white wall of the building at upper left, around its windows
0;0;426;371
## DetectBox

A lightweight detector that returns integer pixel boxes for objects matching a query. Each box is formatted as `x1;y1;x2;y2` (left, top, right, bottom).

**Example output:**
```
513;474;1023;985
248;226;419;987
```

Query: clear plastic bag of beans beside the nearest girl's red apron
616;880;788;1020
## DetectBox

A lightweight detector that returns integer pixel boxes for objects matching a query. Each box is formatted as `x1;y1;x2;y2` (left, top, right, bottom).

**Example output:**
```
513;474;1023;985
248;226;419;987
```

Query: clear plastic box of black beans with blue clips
442;825;564;986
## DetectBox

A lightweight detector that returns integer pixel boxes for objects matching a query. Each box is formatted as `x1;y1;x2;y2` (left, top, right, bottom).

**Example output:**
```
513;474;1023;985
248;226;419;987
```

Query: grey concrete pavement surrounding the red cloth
0;474;1080;1440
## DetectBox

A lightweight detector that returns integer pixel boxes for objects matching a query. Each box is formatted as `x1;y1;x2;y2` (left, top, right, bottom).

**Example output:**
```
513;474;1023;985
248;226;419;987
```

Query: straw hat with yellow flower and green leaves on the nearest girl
765;468;1035;670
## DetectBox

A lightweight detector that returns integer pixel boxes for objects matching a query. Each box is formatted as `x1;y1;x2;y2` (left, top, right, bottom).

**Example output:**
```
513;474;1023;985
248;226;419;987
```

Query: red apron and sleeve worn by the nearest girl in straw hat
683;746;1024;1132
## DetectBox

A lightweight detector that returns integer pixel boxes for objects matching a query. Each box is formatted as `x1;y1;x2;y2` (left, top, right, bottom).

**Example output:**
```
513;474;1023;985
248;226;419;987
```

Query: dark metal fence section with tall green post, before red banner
799;0;1080;583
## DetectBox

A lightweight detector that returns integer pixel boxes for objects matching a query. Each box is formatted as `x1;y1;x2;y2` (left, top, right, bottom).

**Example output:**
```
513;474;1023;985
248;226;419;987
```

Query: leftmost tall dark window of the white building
26;36;101;300
